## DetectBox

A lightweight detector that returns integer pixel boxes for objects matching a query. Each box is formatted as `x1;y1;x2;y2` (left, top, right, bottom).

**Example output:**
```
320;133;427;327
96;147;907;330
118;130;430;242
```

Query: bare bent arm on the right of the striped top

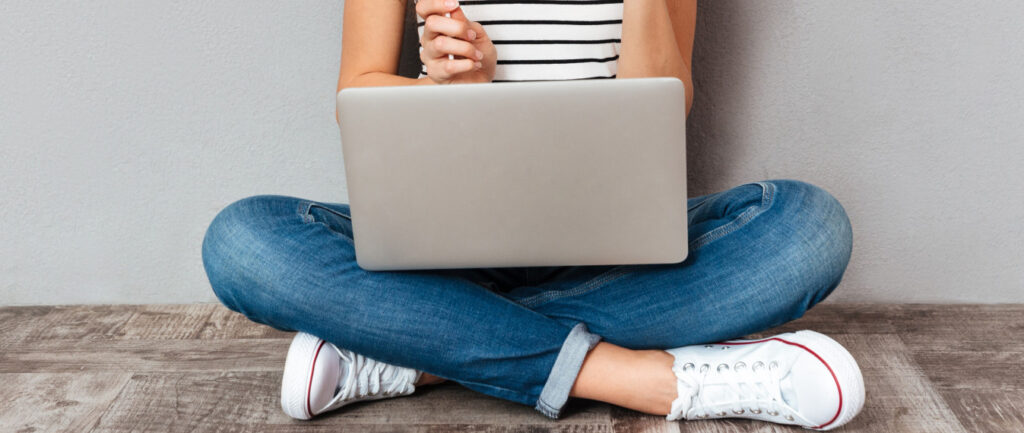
617;0;693;112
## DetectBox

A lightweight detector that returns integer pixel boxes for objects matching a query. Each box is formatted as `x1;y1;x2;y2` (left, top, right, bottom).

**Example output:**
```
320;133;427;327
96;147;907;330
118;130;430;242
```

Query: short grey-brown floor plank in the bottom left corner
0;373;130;432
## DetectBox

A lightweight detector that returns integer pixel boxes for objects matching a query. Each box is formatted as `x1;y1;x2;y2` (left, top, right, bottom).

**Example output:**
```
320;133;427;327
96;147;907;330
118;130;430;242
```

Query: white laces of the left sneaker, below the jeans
335;350;417;401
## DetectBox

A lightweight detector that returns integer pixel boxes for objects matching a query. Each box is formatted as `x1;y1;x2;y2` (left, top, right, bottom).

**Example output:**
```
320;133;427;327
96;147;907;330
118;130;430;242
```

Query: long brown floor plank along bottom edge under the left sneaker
93;372;608;432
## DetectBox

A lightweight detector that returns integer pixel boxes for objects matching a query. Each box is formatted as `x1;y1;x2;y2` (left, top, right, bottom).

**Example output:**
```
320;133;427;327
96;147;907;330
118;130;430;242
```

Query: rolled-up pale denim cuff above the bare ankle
536;322;601;419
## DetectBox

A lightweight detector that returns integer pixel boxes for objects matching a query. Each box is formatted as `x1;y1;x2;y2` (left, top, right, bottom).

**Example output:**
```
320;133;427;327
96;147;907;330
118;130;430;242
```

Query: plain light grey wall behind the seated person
0;0;1024;305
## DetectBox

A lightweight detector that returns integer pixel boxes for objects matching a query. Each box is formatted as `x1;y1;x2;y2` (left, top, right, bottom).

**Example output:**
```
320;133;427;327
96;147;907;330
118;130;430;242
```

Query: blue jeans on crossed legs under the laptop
203;180;852;418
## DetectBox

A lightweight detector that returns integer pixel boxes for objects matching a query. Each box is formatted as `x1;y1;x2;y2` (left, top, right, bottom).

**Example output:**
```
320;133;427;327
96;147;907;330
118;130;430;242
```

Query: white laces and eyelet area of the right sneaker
675;361;793;421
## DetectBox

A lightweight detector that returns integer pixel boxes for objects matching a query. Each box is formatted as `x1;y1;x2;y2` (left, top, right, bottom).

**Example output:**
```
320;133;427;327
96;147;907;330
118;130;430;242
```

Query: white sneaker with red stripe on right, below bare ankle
667;331;864;430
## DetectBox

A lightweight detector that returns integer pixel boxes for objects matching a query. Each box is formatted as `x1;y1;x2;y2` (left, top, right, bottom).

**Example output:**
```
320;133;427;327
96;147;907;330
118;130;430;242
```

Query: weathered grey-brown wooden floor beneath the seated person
0;304;1024;433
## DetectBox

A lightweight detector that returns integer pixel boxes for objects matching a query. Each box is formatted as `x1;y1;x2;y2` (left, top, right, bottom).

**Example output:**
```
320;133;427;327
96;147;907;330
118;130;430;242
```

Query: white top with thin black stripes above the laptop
417;0;623;83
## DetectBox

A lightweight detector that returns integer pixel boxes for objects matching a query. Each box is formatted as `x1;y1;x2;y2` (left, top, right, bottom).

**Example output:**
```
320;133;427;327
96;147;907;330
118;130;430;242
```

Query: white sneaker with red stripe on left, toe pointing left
281;333;420;420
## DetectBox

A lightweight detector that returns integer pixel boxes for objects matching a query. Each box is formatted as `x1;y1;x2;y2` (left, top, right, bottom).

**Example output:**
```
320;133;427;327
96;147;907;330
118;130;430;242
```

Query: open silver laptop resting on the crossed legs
338;78;687;270
